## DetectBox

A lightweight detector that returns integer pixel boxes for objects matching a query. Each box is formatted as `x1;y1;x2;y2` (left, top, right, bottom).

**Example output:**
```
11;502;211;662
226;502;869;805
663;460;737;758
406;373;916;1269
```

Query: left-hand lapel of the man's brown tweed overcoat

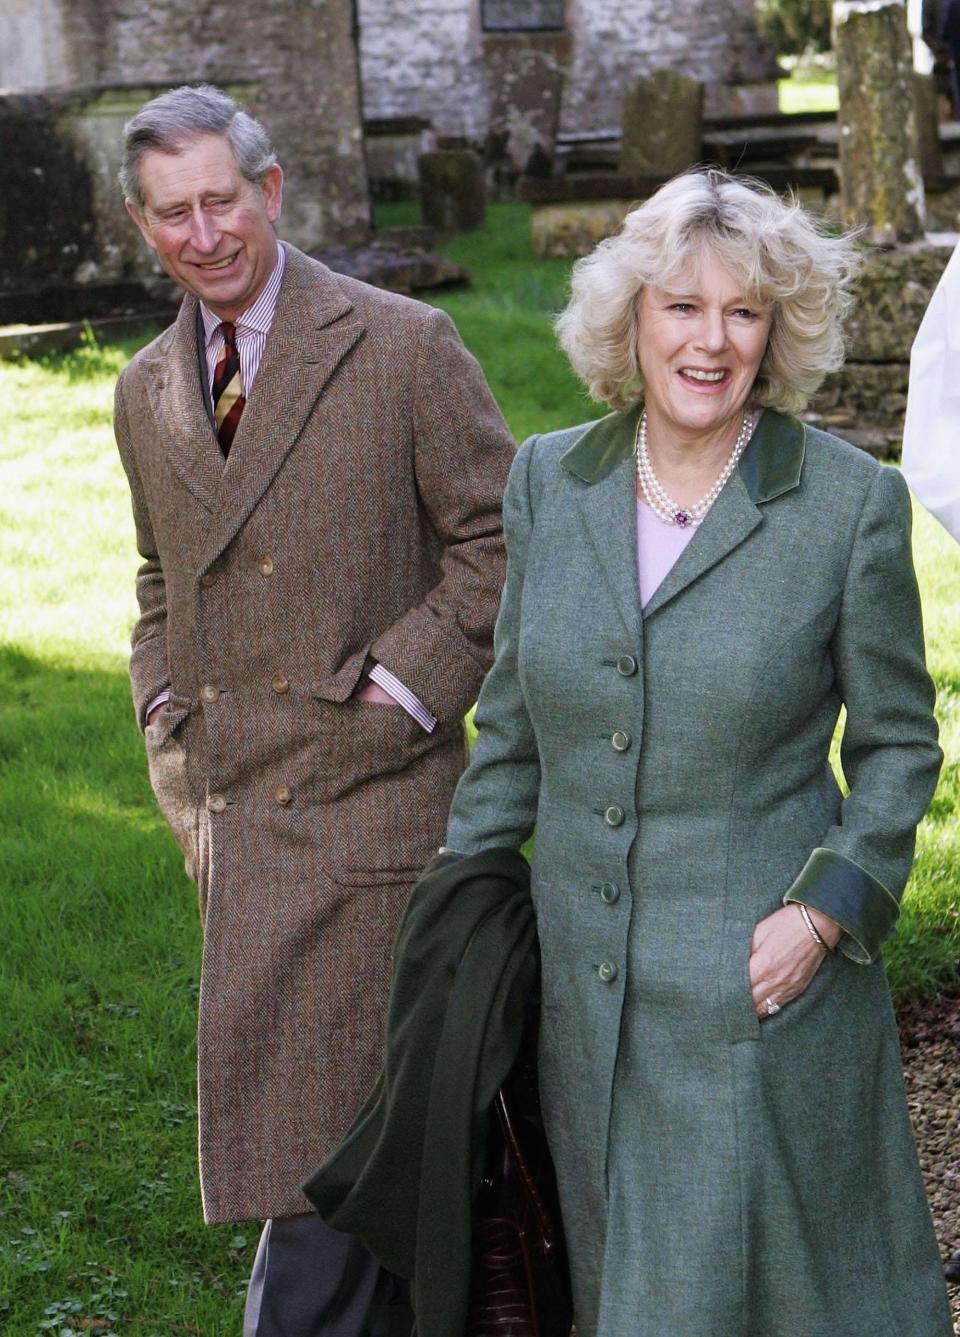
148;297;223;512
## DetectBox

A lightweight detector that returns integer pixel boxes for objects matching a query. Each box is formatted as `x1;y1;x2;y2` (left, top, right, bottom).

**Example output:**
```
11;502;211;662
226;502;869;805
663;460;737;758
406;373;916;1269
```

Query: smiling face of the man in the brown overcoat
127;135;283;321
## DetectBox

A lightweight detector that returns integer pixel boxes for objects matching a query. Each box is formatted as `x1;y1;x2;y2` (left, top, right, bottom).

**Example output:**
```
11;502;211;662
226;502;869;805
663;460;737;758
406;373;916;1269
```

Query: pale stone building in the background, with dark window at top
357;0;775;180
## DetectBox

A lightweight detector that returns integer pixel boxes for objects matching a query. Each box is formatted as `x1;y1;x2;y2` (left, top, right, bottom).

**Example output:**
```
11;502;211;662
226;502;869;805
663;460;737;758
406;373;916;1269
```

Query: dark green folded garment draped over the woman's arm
304;849;539;1337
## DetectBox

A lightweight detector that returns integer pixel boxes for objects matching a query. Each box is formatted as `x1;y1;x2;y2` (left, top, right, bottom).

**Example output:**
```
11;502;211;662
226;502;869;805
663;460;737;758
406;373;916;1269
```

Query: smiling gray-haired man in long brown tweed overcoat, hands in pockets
115;87;512;1337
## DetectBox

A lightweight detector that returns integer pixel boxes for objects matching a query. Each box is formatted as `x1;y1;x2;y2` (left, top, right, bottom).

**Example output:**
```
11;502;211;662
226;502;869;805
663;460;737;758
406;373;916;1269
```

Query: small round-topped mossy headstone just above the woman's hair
620;70;703;176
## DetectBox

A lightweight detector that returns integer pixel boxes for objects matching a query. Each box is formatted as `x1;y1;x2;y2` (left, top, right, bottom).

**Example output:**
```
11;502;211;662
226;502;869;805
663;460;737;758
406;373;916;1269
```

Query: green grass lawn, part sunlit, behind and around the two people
0;206;960;1337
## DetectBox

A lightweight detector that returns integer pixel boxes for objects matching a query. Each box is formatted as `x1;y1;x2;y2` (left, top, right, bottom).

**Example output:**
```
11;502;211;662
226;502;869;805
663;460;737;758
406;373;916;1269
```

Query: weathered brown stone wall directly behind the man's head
0;0;369;255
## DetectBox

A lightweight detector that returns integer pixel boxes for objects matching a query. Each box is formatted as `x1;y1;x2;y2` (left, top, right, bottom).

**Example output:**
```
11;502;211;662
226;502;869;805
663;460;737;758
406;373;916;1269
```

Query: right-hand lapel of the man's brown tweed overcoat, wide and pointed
198;246;364;572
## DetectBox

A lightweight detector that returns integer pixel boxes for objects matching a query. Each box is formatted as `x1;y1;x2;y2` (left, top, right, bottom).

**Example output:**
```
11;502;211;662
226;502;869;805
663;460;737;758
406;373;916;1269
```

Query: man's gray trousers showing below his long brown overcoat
243;1213;413;1337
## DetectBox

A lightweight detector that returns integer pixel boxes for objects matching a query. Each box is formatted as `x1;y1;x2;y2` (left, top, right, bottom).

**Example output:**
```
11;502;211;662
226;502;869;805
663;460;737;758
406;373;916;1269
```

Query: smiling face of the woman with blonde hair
638;250;771;441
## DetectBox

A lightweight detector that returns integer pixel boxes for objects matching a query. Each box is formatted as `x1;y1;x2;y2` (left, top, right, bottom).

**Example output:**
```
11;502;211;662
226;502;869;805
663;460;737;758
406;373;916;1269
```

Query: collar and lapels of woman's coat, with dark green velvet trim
560;404;805;625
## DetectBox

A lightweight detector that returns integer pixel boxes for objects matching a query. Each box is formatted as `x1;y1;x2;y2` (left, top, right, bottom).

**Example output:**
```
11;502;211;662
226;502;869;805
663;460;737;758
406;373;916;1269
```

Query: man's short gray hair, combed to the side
119;84;277;213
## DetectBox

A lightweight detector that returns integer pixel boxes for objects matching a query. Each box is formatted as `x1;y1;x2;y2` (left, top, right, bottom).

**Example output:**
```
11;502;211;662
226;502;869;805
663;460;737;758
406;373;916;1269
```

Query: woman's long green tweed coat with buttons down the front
447;406;952;1337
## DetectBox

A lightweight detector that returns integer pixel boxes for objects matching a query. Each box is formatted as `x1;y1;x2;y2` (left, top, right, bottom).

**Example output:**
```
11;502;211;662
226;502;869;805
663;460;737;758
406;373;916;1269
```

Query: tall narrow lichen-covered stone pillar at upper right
833;0;924;246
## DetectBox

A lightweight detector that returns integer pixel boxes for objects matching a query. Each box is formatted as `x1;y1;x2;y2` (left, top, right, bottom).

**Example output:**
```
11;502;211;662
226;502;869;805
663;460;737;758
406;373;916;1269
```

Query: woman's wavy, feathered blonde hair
556;167;857;412
